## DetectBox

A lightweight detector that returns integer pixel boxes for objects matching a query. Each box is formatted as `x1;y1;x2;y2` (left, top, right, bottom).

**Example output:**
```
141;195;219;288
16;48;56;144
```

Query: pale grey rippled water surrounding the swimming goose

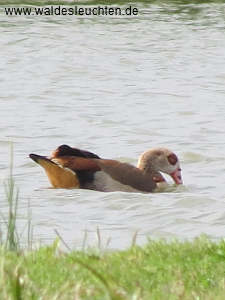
0;2;225;248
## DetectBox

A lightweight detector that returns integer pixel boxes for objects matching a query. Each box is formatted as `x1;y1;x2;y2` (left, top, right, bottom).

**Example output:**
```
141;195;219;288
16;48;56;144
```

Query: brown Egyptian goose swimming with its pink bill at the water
30;145;182;193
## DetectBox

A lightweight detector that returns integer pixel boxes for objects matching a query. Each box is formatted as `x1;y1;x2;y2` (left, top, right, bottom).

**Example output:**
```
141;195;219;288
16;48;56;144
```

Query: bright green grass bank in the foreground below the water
0;237;225;300
